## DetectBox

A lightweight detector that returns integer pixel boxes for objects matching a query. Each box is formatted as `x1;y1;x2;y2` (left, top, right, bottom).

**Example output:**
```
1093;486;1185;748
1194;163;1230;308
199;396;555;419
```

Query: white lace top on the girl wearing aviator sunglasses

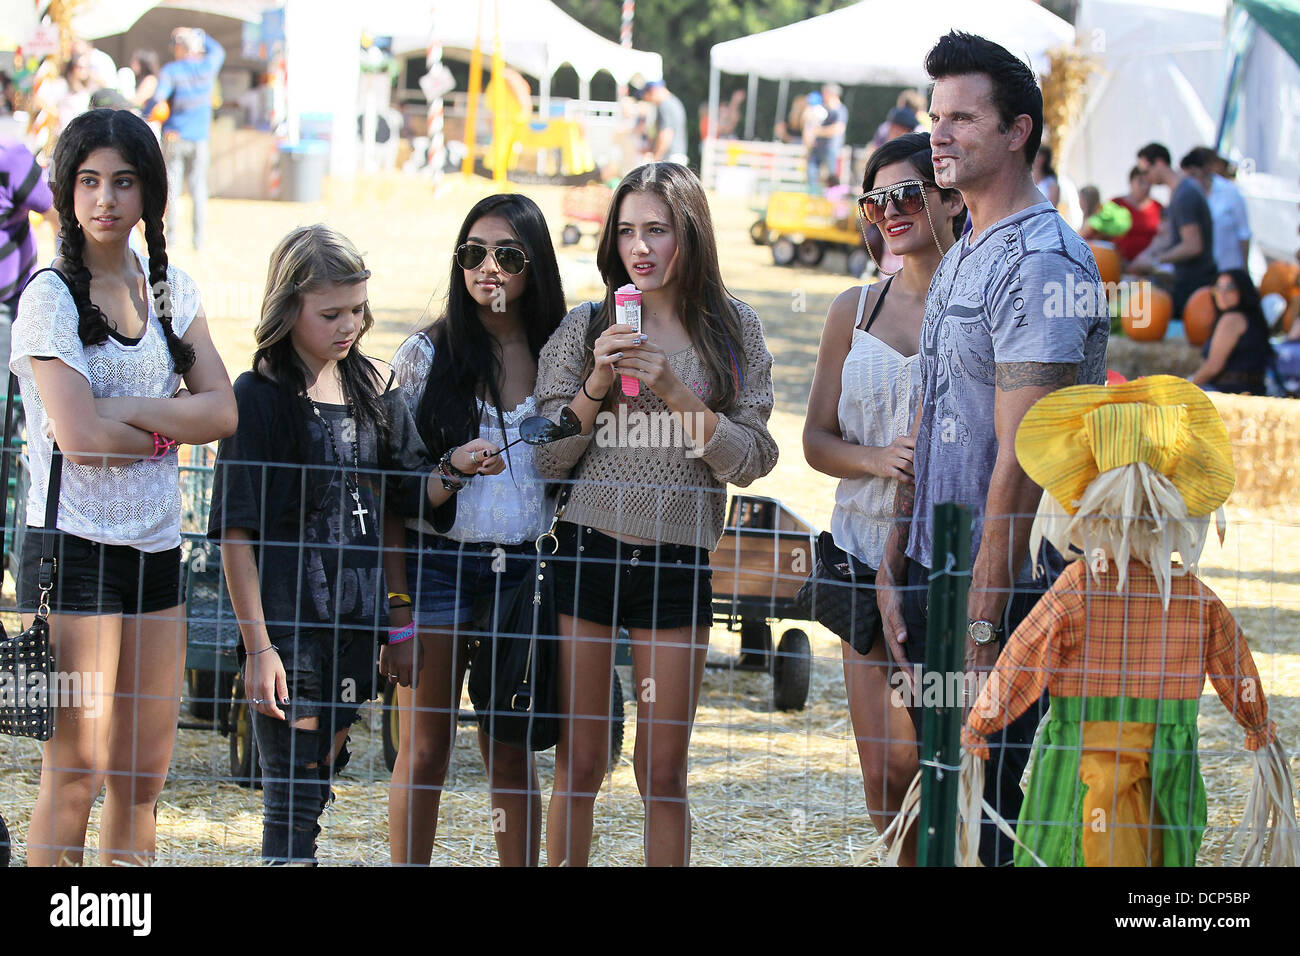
393;332;553;545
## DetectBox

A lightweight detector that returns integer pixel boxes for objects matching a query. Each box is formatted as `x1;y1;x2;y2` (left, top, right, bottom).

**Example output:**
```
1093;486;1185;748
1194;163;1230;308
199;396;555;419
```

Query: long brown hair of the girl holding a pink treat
585;163;749;411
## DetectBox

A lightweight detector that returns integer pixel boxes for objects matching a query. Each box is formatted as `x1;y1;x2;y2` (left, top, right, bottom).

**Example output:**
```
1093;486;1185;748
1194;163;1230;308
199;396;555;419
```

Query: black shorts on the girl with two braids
18;528;185;614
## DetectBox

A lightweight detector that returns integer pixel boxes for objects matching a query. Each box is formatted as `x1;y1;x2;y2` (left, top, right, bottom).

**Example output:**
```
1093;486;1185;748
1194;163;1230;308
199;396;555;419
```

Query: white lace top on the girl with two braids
9;252;199;553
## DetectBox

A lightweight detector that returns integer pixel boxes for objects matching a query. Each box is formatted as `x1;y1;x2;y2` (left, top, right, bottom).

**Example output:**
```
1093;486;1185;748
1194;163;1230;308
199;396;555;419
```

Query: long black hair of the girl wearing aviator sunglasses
416;193;564;457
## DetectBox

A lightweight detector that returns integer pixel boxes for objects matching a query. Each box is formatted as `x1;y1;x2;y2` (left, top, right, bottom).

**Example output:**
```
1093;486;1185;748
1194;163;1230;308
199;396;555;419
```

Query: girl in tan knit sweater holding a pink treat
537;163;777;866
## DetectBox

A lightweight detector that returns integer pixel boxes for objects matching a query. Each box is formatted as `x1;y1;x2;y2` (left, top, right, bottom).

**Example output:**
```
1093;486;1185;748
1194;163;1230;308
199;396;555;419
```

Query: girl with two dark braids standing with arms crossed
10;109;235;865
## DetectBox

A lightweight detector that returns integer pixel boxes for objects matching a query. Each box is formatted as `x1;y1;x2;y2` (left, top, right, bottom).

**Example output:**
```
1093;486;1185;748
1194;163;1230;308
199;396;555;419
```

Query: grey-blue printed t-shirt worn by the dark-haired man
907;202;1110;581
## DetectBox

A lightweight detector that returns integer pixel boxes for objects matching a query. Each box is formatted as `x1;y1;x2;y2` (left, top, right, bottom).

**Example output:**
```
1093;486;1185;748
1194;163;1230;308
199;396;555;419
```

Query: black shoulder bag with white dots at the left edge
0;372;64;740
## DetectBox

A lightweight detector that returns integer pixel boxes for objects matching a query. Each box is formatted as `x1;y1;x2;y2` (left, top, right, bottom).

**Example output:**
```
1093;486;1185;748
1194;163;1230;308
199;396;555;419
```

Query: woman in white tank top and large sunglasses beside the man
803;133;966;860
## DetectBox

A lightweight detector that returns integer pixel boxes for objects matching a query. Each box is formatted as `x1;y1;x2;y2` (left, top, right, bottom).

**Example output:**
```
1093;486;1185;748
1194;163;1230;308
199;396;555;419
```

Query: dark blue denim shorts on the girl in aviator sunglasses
407;529;537;630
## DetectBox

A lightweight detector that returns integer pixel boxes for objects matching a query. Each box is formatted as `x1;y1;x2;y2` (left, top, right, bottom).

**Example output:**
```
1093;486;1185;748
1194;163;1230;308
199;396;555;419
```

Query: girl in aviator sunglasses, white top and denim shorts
386;194;564;866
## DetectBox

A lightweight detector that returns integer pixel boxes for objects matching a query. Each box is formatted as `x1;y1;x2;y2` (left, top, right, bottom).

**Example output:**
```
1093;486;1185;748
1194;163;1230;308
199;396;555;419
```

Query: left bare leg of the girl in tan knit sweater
546;614;614;866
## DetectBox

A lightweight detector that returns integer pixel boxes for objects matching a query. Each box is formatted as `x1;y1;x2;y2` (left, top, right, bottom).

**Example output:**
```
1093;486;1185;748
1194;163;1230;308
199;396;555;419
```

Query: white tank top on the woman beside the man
831;280;920;567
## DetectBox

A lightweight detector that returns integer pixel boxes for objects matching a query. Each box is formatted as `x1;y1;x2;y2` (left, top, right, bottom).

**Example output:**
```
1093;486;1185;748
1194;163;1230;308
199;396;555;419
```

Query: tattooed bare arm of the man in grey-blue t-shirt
967;362;1079;666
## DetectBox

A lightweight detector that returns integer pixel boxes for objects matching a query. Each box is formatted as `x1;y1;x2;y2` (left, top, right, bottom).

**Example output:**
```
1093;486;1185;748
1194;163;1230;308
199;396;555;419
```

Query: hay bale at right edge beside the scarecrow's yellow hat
1209;392;1300;509
